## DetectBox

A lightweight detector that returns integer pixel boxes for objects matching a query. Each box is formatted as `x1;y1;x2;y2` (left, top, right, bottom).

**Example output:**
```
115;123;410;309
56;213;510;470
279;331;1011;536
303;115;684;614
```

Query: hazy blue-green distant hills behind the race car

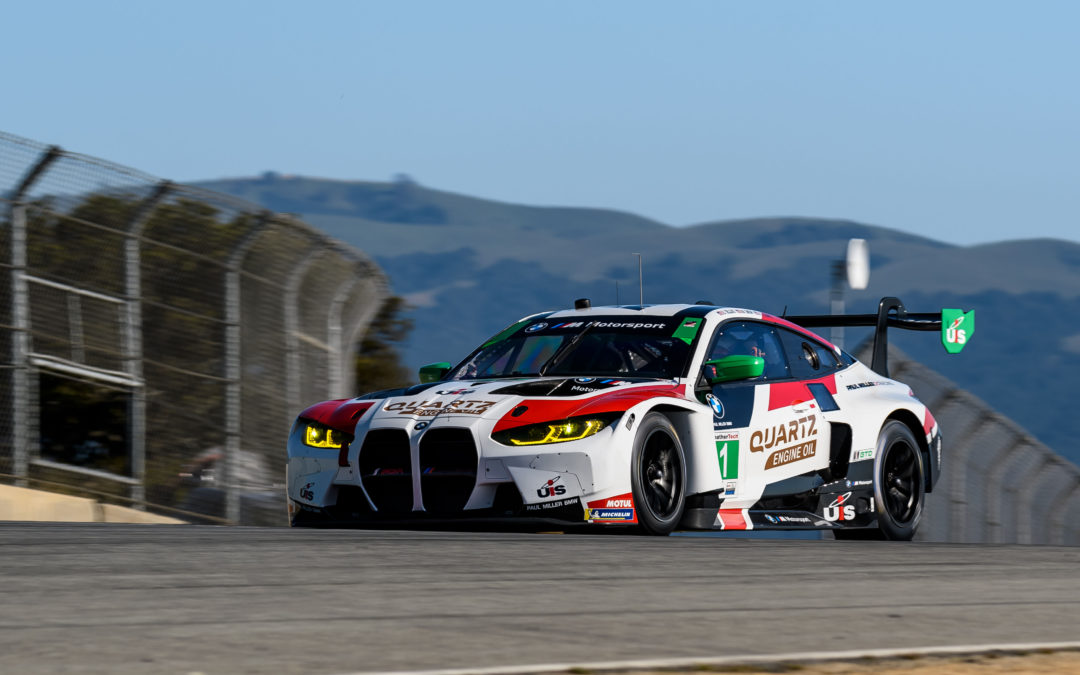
198;174;1080;463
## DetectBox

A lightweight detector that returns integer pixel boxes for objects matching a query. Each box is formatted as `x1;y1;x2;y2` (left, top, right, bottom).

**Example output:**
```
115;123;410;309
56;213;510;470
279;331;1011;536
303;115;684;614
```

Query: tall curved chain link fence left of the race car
0;133;387;524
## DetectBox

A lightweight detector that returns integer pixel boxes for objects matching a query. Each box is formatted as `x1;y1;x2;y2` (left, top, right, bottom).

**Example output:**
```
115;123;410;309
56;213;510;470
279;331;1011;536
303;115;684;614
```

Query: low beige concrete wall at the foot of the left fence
0;485;184;525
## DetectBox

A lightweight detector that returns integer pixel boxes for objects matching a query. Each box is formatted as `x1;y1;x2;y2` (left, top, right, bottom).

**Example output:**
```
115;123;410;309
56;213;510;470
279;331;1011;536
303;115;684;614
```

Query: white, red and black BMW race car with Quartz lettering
287;298;974;540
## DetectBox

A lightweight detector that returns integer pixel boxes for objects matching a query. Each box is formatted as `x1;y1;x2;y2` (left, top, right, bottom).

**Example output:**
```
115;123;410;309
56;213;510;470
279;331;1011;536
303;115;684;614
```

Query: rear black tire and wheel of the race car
870;420;926;541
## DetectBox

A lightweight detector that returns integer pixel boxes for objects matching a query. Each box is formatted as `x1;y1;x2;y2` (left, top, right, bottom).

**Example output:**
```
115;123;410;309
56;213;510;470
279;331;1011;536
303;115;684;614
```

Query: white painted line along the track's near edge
338;642;1080;675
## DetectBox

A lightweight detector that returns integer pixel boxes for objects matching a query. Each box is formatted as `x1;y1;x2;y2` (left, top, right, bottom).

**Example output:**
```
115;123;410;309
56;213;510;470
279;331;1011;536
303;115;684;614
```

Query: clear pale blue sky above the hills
0;0;1080;244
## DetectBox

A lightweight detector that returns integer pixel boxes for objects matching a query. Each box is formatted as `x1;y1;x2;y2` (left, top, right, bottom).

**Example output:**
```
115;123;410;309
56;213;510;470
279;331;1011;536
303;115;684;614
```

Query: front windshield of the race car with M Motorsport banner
447;316;690;380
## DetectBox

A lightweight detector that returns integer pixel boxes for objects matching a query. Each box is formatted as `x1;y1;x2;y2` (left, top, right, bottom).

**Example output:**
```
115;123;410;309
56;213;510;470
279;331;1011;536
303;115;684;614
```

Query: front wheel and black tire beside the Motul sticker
630;413;686;536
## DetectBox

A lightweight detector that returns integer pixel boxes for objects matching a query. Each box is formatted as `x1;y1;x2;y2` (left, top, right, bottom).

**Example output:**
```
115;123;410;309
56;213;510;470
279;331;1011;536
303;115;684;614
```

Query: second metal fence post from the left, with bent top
123;180;173;509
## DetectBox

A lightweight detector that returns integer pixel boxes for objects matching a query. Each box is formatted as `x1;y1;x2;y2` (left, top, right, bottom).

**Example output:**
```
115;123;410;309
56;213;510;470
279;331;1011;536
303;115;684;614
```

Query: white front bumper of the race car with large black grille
286;418;630;524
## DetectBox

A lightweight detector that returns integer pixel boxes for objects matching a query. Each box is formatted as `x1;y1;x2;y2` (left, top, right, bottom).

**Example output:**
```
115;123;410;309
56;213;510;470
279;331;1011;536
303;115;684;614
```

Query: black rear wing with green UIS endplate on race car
784;297;975;377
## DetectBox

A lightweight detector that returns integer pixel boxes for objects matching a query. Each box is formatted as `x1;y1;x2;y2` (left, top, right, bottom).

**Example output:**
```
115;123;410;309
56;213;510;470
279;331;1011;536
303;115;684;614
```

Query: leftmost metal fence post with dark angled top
11;146;63;487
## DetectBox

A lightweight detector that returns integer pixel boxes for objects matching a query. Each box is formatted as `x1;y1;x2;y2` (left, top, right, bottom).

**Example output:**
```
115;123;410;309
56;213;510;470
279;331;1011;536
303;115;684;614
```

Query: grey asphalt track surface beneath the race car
0;523;1080;675
